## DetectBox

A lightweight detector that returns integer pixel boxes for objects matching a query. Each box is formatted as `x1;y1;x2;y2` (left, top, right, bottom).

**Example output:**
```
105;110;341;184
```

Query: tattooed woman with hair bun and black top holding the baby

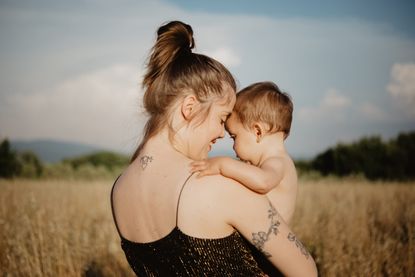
111;21;316;276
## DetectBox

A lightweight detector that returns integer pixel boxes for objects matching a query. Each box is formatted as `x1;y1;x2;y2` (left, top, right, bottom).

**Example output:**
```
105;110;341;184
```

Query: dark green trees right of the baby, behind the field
296;132;415;181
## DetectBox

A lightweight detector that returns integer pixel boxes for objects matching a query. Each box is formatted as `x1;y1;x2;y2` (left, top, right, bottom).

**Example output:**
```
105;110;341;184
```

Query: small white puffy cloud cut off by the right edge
387;63;415;118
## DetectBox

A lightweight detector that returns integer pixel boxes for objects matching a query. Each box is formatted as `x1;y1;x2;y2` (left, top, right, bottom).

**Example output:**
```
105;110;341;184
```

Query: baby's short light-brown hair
233;82;293;138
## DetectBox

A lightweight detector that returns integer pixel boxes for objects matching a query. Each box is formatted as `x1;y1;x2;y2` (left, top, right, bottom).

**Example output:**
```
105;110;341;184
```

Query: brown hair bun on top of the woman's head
157;21;195;51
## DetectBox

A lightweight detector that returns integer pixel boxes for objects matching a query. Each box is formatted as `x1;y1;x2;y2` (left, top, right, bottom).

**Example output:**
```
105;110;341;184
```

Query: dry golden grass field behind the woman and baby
0;179;415;276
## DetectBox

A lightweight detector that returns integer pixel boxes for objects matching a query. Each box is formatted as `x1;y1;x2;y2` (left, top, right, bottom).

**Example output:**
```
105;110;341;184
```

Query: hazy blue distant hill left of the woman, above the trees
10;140;108;163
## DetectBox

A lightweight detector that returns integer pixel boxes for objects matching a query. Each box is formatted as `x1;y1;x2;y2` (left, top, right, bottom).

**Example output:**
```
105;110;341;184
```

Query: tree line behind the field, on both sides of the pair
0;131;415;181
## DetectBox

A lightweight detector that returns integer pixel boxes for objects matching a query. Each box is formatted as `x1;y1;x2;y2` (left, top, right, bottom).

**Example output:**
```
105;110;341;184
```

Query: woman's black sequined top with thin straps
111;178;267;276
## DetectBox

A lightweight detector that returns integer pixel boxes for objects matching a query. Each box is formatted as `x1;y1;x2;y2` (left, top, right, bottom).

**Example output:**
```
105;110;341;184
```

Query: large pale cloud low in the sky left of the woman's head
0;64;144;151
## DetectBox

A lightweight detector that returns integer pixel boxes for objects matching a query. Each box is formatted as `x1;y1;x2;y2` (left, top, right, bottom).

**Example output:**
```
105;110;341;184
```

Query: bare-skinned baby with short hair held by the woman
191;82;297;224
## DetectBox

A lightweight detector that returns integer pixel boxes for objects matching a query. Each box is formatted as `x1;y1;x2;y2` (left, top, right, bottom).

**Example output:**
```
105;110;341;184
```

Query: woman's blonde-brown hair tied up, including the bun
131;21;236;161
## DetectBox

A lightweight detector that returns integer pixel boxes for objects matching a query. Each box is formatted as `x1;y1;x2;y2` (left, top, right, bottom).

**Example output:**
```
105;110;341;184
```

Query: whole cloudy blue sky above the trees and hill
0;0;415;158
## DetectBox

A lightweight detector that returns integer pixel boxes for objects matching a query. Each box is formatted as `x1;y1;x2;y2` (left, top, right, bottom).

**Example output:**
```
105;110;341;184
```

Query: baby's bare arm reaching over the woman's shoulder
191;157;283;194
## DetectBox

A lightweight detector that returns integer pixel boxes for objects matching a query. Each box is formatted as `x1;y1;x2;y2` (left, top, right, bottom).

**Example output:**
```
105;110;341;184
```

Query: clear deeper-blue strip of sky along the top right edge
168;0;415;36
